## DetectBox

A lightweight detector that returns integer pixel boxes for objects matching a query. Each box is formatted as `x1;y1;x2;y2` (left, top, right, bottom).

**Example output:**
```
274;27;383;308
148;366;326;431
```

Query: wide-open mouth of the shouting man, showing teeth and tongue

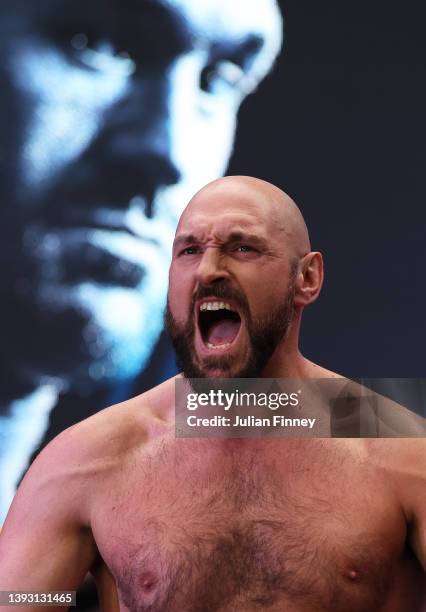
198;301;241;351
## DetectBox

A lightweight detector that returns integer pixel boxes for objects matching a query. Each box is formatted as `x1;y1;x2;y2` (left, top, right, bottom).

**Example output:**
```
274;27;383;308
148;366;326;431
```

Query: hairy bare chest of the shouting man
94;440;422;612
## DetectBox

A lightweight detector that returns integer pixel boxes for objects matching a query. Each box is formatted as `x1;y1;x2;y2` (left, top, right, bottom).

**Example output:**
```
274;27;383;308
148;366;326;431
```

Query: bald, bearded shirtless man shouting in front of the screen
0;177;426;612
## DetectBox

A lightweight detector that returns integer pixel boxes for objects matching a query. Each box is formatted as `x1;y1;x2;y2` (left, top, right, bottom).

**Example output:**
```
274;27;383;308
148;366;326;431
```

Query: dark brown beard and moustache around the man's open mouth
165;262;298;378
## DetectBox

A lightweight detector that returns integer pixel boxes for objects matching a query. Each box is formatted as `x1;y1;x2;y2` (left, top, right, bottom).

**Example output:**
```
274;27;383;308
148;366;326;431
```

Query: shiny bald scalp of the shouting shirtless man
177;176;311;257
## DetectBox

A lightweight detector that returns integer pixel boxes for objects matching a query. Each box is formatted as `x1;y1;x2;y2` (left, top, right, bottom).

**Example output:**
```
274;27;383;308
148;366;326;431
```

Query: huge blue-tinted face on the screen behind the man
0;0;281;390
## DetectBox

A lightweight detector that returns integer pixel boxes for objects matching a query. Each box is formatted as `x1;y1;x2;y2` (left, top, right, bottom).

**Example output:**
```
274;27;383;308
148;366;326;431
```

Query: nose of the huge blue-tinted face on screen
88;53;203;216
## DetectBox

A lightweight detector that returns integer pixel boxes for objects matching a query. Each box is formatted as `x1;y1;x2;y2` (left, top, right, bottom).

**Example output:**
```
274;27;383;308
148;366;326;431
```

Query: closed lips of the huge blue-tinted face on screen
27;198;168;288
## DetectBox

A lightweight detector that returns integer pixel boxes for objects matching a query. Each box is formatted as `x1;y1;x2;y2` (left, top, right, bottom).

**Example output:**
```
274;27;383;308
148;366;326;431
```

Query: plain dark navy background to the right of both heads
228;0;426;377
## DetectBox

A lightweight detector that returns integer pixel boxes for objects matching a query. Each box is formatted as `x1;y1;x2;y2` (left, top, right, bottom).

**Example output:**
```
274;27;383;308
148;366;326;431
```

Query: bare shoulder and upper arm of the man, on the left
0;383;174;590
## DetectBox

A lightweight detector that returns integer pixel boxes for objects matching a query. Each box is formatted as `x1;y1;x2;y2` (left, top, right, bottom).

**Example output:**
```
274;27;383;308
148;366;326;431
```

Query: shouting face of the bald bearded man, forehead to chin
166;185;298;378
